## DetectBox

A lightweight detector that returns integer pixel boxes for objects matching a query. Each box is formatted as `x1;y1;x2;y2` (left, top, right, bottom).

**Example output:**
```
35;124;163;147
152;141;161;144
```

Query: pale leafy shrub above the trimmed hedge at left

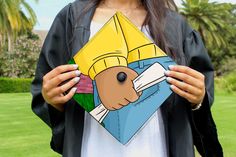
0;35;41;78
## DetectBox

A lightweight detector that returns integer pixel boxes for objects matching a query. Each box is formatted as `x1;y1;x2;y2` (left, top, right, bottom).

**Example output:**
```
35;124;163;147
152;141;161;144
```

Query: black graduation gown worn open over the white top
31;0;223;157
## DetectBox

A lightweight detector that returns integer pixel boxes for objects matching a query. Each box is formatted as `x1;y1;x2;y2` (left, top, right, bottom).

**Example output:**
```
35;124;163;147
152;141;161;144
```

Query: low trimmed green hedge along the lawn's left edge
0;77;32;93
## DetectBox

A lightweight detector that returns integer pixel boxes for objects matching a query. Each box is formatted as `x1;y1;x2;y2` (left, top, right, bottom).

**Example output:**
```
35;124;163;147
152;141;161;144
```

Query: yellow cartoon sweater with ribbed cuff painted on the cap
74;12;166;79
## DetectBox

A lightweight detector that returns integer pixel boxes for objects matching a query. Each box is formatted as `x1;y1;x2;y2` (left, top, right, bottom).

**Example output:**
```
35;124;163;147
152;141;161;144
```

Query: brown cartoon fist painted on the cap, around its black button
95;66;139;110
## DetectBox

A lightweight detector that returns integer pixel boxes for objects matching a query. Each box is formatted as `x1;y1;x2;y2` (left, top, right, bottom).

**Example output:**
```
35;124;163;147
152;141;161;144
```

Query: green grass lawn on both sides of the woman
0;93;236;157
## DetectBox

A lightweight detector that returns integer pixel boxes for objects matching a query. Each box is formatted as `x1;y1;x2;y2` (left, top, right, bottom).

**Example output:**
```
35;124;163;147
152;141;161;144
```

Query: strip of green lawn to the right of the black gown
212;93;236;157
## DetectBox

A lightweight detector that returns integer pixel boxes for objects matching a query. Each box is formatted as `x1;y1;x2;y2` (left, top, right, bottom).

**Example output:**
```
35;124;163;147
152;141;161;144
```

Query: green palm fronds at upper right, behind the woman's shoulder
180;0;232;47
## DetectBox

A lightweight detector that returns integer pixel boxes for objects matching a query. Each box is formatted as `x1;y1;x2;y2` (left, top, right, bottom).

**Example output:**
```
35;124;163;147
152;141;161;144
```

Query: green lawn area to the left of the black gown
0;93;59;157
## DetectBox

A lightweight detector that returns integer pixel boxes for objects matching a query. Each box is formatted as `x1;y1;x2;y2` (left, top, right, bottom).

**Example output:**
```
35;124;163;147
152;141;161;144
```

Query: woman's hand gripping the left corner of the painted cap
42;64;81;111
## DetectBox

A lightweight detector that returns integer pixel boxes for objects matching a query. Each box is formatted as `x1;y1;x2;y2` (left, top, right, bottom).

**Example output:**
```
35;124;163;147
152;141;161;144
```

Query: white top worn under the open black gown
81;21;167;157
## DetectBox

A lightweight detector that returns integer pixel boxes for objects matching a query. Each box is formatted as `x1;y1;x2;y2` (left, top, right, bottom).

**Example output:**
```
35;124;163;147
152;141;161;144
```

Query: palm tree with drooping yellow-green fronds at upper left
0;0;37;51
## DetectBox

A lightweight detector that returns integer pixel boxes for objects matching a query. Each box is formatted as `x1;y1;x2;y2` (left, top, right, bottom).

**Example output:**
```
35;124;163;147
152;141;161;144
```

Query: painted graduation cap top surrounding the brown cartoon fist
70;12;175;144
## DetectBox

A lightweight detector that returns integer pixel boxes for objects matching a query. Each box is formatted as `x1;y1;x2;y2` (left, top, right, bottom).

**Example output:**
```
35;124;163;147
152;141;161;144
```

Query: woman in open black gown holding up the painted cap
32;0;223;157
